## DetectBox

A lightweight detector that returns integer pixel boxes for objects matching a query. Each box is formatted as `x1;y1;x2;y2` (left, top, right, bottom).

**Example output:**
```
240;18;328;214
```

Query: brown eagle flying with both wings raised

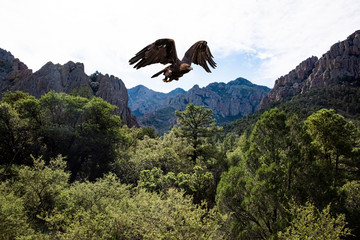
129;38;216;82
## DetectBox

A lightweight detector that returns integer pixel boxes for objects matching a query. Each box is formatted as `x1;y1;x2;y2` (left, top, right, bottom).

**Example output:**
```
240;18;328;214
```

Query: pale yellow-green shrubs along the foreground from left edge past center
0;156;225;239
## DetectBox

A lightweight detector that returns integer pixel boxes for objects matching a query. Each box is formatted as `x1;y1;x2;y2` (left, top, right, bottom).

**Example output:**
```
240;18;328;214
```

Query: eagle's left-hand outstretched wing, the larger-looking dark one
129;38;178;69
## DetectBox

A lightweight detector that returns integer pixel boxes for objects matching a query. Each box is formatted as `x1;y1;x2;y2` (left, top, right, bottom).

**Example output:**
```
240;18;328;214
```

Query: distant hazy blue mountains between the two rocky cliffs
128;78;270;133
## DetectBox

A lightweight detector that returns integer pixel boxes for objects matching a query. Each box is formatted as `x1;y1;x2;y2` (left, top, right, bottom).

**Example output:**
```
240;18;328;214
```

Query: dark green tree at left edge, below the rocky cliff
0;91;41;166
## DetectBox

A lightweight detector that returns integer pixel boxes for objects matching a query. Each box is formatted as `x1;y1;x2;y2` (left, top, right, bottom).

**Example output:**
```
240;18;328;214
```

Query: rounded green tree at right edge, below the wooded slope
305;109;359;186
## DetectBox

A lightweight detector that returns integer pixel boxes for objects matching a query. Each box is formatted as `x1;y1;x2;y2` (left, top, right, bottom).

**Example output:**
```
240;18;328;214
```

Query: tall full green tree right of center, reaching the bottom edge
216;108;294;239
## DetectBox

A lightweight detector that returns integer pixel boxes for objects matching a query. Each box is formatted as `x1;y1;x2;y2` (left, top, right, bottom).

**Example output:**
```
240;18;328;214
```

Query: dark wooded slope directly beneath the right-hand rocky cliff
224;83;360;138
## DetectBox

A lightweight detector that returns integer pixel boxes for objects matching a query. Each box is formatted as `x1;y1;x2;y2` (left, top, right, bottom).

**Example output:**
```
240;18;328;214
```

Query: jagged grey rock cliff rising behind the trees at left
0;49;138;126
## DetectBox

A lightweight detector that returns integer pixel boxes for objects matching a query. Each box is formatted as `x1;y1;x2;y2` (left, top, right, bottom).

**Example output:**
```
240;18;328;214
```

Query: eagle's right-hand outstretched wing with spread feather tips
182;41;216;72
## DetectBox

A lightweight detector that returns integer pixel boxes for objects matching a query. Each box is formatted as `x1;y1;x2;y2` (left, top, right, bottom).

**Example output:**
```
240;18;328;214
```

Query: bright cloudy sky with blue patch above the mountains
0;0;360;92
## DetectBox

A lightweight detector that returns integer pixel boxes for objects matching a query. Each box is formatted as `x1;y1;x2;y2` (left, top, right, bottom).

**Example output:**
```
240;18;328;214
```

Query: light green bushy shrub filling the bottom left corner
0;156;70;239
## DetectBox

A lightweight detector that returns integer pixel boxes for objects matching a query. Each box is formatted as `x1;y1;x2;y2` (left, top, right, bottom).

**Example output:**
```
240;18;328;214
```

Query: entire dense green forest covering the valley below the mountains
0;92;360;239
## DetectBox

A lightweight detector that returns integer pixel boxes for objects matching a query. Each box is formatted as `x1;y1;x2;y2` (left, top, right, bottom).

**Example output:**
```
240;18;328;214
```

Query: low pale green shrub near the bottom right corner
278;203;350;240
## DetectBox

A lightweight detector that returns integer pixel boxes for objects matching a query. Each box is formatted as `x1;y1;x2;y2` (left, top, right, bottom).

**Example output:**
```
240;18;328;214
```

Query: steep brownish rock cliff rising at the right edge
261;30;360;107
